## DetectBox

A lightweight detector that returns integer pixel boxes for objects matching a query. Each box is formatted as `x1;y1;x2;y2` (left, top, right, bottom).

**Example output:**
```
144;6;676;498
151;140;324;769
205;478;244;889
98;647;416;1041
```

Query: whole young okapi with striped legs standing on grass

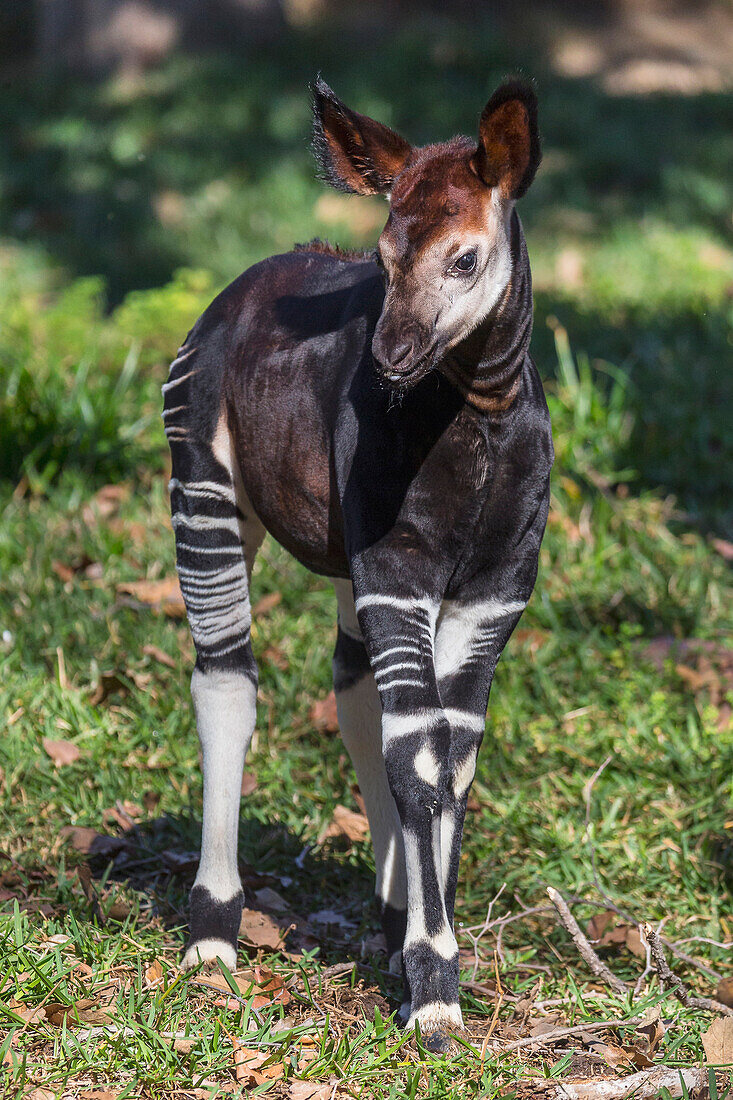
163;80;553;1049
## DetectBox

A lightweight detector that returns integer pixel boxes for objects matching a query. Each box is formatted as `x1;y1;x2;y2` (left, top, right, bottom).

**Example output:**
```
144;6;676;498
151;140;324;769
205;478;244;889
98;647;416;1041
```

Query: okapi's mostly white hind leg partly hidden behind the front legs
333;580;407;972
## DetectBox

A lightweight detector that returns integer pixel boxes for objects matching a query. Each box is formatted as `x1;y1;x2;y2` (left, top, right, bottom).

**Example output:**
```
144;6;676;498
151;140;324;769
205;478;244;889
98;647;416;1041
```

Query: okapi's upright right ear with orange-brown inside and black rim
473;80;541;201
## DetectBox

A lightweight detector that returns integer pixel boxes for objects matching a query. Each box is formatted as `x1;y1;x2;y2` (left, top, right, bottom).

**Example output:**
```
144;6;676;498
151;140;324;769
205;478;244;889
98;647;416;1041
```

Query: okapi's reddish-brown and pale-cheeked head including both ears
313;79;540;389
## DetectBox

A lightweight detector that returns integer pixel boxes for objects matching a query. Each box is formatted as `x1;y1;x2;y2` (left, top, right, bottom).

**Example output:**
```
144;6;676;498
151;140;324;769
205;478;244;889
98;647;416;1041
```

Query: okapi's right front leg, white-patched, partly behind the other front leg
435;600;524;926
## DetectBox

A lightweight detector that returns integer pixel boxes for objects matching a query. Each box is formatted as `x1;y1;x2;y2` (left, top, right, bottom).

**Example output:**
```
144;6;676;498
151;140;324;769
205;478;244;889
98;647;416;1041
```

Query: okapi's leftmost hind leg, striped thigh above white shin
163;349;263;967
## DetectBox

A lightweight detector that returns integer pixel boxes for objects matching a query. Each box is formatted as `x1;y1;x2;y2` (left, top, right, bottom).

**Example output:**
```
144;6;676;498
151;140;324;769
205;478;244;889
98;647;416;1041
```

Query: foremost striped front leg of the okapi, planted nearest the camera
357;595;462;1049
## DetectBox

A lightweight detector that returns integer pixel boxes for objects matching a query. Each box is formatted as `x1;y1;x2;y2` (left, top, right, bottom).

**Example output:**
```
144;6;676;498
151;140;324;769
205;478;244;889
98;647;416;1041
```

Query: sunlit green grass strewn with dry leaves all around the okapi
0;6;733;1100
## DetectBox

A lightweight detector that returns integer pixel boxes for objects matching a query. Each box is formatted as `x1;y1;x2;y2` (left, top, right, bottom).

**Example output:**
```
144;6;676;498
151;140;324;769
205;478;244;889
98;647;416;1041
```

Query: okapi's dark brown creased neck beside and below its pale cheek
439;213;532;416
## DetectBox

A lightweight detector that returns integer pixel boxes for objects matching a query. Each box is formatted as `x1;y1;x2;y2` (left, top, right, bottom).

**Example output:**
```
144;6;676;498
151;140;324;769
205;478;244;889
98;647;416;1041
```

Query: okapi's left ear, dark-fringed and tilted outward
310;77;412;195
